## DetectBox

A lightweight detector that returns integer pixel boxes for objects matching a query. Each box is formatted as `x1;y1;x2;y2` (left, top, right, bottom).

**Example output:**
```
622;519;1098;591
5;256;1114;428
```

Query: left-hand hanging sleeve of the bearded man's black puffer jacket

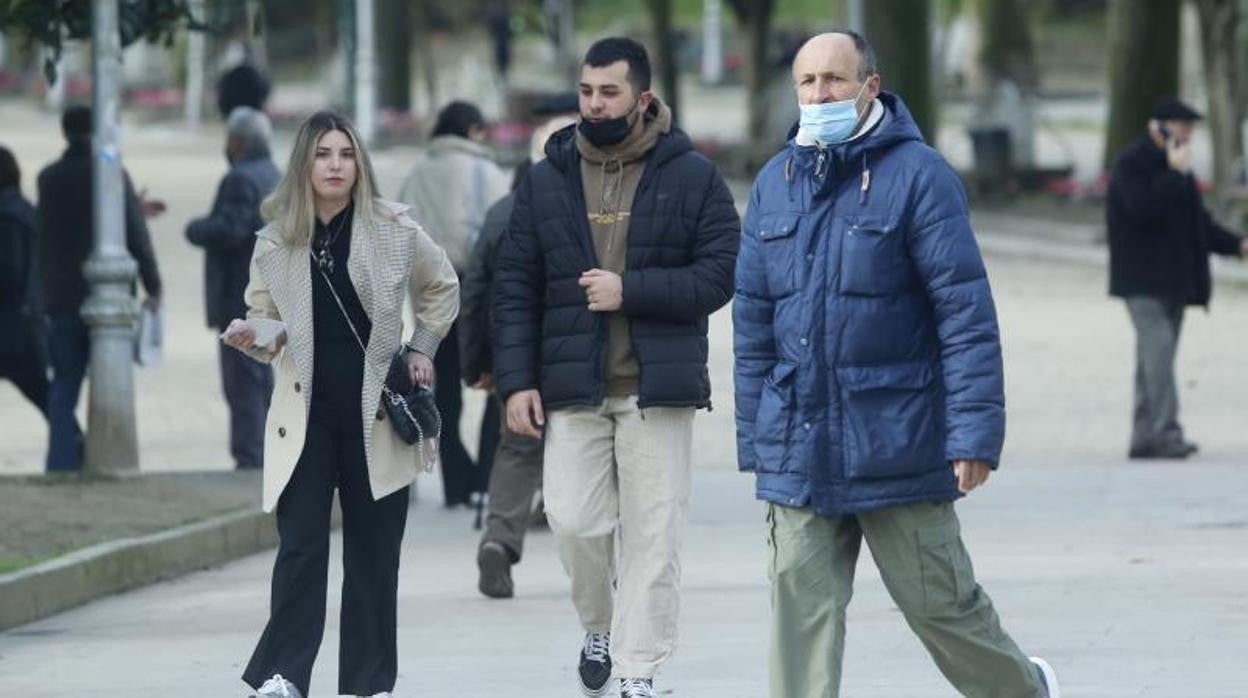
492;177;545;402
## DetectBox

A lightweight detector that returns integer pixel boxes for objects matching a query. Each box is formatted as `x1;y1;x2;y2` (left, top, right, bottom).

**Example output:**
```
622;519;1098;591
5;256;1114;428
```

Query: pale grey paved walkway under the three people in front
0;252;1248;698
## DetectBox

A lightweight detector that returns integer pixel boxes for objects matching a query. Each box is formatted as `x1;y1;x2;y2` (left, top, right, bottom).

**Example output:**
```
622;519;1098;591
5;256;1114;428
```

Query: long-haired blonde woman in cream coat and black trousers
222;112;459;698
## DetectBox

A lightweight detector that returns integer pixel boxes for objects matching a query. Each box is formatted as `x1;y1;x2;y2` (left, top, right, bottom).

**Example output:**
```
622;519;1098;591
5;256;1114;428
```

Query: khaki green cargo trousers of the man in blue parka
768;502;1046;698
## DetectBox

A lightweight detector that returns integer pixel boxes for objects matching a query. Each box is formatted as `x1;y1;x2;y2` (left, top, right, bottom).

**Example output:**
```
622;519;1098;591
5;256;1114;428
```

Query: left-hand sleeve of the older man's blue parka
733;183;776;471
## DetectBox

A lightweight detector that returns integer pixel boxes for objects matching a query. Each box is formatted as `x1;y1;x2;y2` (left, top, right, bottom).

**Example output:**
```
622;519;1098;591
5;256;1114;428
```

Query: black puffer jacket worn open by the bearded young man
493;126;741;410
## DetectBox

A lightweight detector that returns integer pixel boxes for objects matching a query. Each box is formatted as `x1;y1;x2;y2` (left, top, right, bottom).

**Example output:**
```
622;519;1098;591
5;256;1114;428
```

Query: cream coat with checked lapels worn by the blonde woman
246;199;459;512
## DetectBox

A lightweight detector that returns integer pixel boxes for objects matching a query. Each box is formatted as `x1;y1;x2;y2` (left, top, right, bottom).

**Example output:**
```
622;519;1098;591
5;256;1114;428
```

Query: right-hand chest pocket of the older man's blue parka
837;216;914;296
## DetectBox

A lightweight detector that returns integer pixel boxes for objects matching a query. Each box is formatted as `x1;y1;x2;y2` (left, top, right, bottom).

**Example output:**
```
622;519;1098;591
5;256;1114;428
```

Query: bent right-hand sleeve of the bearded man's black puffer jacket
620;169;741;322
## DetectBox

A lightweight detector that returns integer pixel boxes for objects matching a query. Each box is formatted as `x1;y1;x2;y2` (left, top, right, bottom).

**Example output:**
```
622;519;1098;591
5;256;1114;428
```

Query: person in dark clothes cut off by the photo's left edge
0;146;47;418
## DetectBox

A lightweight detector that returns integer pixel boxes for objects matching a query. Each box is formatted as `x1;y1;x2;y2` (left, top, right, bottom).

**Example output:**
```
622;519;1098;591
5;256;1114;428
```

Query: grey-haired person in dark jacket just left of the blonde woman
186;106;281;469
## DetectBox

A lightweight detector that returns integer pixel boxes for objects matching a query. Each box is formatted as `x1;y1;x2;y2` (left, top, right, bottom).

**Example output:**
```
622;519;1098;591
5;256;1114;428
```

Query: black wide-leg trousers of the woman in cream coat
243;413;408;696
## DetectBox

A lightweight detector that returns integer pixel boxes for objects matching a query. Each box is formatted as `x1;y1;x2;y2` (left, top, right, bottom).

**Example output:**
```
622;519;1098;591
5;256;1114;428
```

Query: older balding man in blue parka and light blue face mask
733;31;1058;698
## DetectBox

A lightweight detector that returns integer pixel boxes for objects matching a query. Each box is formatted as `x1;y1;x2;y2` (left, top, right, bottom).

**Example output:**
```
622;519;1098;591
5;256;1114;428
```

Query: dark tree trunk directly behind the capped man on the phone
1104;0;1179;169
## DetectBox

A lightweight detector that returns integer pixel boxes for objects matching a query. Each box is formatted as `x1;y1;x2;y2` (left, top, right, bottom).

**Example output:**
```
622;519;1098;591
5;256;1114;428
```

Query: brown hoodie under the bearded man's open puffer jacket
577;97;671;397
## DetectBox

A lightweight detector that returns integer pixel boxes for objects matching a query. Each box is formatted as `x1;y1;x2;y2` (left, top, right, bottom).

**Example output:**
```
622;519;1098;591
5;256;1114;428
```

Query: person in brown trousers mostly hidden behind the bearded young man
469;109;577;598
